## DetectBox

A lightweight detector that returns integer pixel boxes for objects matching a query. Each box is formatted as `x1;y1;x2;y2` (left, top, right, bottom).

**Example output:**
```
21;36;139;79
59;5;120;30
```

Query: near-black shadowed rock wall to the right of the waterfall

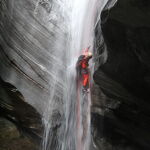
93;0;150;150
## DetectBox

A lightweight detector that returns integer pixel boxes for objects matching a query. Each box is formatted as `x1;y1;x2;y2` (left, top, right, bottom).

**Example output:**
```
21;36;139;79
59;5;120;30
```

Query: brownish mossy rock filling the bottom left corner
0;117;38;150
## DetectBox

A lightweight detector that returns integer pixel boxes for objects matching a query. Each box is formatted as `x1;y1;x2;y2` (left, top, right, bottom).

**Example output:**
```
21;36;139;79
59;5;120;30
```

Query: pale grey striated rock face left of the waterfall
0;0;67;113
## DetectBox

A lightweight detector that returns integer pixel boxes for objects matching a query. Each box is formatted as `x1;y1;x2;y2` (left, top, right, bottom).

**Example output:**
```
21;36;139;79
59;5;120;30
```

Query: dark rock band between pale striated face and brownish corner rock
0;79;43;141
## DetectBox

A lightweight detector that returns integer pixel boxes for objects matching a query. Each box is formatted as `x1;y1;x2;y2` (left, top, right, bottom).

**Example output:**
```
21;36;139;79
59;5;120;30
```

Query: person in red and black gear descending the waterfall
76;47;92;92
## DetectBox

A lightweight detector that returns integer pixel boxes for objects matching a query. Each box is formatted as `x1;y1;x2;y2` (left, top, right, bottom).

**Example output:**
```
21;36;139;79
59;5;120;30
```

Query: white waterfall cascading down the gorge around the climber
35;0;118;150
